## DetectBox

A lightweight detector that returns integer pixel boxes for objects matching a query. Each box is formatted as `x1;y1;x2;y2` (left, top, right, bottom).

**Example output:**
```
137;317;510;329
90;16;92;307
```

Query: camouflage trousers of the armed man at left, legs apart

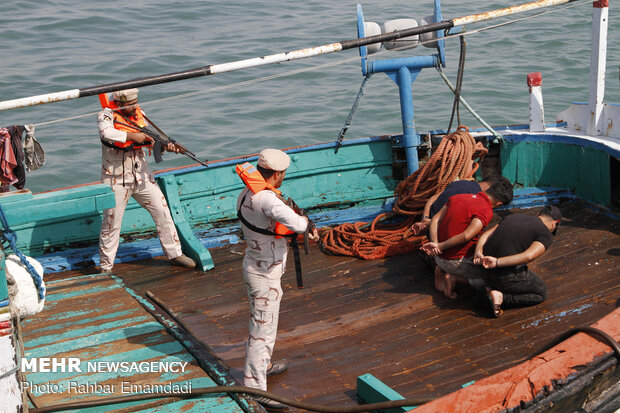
99;180;183;271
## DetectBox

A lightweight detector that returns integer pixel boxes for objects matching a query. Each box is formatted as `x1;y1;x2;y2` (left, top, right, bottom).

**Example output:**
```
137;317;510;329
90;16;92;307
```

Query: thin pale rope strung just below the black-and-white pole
30;0;592;127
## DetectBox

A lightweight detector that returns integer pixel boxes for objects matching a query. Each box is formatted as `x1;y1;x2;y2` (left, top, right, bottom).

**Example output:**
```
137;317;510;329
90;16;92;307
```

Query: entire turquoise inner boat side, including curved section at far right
0;136;612;264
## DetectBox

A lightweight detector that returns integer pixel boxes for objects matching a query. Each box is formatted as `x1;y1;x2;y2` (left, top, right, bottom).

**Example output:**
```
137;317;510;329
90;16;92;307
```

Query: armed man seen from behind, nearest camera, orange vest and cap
237;149;319;409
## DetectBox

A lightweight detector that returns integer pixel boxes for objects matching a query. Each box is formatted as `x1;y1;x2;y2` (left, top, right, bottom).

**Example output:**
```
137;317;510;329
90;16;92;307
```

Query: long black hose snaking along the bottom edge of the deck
29;386;434;413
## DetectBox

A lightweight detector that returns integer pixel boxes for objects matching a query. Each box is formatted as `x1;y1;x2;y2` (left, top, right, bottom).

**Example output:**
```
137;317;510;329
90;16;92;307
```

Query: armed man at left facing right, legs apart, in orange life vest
97;89;196;272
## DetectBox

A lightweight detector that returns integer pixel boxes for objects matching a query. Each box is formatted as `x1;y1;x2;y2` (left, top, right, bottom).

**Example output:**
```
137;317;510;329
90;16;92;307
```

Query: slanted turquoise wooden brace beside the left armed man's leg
159;176;215;271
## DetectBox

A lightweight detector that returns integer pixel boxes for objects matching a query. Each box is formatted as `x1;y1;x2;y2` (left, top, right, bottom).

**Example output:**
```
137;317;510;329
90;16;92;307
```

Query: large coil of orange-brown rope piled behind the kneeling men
321;125;488;260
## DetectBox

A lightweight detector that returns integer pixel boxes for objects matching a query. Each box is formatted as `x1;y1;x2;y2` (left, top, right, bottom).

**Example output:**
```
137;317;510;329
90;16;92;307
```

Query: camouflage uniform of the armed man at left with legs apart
97;109;182;271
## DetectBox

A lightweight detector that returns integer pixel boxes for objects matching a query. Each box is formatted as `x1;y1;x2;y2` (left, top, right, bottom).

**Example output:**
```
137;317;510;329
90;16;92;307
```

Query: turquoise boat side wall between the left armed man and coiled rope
158;138;395;225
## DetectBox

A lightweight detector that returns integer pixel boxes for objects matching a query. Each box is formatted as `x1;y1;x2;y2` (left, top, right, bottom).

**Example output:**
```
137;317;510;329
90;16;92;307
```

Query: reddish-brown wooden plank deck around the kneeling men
46;203;620;405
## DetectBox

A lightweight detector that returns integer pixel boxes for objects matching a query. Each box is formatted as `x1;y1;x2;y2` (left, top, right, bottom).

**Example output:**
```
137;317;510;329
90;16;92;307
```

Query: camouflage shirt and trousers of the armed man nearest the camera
237;188;308;390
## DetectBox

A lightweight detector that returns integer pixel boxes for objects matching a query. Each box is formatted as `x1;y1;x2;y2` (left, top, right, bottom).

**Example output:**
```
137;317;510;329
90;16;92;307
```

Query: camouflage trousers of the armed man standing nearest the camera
243;256;284;390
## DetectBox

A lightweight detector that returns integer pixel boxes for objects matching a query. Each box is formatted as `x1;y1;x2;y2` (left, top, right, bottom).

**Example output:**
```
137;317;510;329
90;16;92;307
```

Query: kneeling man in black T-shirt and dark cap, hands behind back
474;205;562;317
